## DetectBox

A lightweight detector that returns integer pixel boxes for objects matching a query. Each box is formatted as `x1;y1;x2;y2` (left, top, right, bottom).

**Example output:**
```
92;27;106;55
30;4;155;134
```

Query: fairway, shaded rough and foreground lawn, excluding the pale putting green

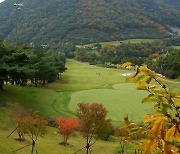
0;60;138;154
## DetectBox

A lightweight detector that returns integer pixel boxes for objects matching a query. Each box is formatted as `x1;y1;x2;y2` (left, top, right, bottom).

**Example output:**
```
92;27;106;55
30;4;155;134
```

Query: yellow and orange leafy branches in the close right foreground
127;66;180;154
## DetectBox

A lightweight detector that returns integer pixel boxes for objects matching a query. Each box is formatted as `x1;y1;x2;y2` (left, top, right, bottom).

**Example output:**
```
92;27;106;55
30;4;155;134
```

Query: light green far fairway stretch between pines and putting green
50;60;129;90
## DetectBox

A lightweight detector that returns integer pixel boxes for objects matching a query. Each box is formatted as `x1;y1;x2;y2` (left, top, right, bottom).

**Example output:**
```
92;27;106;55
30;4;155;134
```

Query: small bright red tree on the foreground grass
57;117;78;146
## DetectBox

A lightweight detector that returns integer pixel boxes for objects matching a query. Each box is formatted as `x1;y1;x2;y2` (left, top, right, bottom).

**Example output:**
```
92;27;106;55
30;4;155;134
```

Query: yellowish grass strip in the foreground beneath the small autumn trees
0;127;126;154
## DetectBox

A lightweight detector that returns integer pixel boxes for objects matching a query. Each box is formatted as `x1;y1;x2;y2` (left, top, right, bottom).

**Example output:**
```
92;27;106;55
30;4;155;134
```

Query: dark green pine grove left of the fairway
0;41;66;89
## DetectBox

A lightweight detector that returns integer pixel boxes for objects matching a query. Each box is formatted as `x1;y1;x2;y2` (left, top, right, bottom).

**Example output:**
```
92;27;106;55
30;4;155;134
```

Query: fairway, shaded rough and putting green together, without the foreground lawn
0;60;152;125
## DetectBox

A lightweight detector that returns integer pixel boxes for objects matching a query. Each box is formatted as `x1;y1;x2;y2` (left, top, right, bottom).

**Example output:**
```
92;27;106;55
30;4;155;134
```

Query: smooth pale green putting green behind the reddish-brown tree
69;83;153;122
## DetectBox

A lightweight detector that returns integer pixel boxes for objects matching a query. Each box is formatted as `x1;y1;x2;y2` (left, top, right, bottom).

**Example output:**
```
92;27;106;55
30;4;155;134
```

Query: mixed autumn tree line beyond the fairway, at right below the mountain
73;39;180;78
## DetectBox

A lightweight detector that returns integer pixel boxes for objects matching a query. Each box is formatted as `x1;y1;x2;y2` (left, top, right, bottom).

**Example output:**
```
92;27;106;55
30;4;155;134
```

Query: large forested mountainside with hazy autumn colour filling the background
0;0;180;48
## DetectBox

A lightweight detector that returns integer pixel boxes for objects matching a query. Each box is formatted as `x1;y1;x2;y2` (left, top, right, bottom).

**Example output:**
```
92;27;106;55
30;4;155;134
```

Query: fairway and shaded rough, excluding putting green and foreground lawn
0;60;135;125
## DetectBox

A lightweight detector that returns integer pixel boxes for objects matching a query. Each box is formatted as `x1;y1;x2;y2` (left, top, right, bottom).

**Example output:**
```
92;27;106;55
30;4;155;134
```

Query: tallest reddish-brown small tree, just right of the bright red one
77;103;107;154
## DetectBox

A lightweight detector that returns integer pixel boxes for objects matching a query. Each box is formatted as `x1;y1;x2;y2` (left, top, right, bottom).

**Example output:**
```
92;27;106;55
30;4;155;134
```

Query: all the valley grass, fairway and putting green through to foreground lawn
0;60;179;154
